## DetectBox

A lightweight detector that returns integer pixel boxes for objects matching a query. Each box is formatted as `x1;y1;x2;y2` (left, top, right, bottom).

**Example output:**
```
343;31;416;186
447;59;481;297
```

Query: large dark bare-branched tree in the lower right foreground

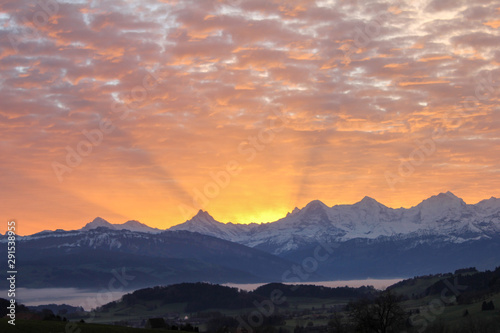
351;291;406;333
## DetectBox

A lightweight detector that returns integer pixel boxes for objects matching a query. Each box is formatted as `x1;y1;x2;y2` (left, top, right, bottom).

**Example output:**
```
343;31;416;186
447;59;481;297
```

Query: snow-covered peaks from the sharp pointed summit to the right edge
171;192;500;254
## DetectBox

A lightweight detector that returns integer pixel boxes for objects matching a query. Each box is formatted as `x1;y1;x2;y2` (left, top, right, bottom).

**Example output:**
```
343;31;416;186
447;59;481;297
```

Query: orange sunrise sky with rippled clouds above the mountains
0;0;500;235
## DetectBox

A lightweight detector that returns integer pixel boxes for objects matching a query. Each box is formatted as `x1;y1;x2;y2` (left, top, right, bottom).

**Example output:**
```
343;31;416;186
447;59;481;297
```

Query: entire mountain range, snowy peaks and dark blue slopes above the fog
0;192;500;287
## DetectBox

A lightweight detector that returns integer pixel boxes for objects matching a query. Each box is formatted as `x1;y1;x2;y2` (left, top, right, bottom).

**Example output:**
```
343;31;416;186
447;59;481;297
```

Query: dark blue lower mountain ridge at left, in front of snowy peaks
11;227;292;290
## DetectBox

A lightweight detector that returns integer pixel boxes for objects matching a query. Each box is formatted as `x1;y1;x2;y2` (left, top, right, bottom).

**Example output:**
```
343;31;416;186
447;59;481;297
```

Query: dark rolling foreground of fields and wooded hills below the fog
4;271;500;333
